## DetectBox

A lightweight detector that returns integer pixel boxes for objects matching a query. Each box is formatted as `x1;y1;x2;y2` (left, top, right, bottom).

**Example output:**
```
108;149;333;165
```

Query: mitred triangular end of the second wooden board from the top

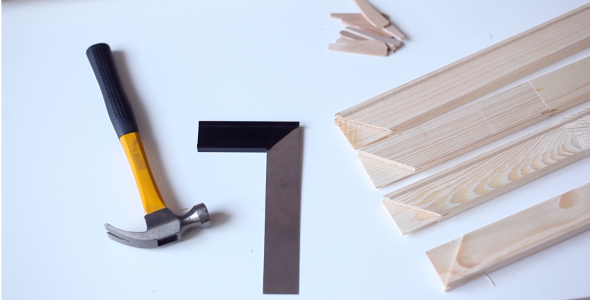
358;151;416;188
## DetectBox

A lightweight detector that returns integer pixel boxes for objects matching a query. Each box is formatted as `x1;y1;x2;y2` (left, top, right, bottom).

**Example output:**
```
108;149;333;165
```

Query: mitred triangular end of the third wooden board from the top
382;198;441;235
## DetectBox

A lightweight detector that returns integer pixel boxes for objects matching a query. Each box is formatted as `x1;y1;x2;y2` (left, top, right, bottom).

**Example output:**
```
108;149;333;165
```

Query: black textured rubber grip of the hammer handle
86;44;139;138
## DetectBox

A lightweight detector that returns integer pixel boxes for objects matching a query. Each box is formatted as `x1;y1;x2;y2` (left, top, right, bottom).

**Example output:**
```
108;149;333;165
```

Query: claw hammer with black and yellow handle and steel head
86;44;211;248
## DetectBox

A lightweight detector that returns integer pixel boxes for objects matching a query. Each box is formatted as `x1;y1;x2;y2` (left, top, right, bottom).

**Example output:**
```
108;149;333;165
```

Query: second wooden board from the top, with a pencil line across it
359;57;590;187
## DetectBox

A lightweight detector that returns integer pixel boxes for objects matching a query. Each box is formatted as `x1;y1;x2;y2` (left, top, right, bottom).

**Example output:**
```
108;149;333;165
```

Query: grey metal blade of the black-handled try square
263;128;301;294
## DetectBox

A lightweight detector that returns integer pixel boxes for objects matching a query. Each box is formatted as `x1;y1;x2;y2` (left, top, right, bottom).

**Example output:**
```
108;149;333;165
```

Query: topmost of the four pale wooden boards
335;4;590;149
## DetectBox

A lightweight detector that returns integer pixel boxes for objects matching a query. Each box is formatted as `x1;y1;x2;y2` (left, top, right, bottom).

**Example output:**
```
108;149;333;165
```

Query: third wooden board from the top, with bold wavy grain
382;108;590;234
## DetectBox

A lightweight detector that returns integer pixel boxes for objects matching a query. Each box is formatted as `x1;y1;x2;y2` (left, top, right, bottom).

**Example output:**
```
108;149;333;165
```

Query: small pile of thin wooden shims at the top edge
329;0;405;56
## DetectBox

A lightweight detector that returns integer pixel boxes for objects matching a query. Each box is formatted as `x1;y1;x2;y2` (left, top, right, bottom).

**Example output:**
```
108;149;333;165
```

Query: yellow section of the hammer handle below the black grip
119;132;166;214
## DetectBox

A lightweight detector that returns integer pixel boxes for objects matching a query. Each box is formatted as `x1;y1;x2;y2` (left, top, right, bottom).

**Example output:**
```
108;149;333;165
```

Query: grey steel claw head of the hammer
105;203;211;248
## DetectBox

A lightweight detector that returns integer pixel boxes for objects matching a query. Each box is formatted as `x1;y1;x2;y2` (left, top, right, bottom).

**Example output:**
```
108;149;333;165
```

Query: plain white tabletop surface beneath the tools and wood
1;0;590;300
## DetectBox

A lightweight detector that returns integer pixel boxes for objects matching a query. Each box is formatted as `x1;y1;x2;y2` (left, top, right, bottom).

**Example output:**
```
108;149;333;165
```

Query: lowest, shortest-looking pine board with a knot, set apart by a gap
426;183;590;291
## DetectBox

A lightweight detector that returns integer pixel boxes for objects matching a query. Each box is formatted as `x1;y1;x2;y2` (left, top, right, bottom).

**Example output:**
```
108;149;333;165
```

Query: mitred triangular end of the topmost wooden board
334;117;392;149
